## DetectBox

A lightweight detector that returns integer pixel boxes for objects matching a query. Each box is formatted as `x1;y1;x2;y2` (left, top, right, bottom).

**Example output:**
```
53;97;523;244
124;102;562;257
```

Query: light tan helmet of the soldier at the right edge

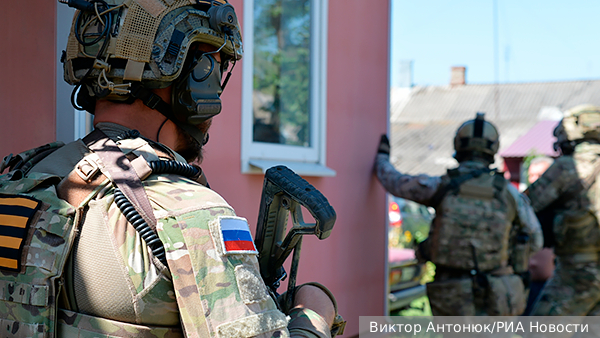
553;104;600;154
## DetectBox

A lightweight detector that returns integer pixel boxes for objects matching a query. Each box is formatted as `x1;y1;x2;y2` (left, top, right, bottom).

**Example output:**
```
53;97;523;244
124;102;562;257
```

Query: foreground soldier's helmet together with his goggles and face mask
60;0;243;144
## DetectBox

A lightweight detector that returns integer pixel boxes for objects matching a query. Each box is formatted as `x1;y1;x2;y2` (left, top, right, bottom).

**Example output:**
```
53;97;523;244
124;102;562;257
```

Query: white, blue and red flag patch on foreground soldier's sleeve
219;216;258;255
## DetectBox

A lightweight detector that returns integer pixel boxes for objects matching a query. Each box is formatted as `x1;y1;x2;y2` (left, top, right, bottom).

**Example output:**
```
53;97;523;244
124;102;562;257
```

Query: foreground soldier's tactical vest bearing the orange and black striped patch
0;134;200;338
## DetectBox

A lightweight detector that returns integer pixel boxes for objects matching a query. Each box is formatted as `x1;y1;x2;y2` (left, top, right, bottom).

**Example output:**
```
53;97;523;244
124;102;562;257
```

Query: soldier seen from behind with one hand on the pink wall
375;113;542;316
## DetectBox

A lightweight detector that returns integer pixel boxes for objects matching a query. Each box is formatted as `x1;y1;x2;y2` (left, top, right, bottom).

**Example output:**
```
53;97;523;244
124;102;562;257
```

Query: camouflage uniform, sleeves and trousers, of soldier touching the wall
375;153;542;316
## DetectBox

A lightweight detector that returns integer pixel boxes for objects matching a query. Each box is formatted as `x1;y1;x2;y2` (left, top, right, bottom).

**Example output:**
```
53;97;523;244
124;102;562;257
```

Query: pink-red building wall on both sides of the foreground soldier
0;0;390;337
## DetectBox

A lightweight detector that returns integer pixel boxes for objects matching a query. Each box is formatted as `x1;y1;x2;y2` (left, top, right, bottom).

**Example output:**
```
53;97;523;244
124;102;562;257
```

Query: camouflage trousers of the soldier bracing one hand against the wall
427;275;527;316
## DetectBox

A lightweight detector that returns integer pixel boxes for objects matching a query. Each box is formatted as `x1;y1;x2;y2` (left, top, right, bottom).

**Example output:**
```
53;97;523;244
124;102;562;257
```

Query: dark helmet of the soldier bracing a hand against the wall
454;113;500;163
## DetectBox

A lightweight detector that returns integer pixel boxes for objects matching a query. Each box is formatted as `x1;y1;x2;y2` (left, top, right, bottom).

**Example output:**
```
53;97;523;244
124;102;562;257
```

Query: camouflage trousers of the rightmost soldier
531;257;600;316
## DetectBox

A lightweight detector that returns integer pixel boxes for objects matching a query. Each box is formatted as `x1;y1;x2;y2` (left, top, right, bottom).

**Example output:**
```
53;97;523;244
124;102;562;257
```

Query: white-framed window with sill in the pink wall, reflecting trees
242;0;335;176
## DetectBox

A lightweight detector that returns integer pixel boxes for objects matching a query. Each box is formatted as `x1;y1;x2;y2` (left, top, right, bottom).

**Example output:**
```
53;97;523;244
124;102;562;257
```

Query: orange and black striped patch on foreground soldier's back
0;194;42;271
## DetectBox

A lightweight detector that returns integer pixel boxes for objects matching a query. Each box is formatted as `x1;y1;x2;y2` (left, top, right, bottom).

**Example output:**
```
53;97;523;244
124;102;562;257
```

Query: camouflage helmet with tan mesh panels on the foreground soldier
63;0;243;100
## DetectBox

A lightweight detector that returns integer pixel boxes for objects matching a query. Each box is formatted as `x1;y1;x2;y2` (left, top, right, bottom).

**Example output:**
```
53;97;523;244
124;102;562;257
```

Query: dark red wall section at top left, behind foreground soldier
0;0;56;159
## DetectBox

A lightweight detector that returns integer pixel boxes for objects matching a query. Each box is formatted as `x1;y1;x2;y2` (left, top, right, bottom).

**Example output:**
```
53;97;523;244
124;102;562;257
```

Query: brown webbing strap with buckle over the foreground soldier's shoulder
83;129;156;231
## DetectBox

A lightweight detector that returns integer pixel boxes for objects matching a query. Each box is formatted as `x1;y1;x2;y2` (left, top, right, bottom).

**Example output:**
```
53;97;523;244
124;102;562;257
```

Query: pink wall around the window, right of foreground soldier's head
202;0;390;337
